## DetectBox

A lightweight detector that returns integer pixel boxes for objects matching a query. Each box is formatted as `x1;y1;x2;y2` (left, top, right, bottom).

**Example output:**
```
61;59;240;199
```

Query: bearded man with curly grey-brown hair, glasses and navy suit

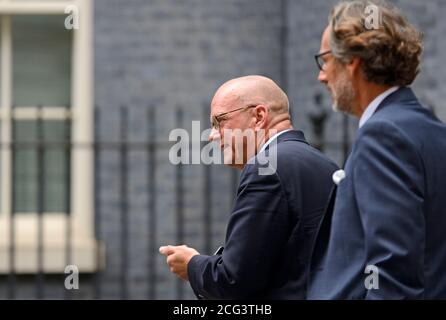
307;0;446;299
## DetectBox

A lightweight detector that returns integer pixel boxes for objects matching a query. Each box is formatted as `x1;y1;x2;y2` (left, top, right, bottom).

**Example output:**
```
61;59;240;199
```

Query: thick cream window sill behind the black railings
0;214;105;274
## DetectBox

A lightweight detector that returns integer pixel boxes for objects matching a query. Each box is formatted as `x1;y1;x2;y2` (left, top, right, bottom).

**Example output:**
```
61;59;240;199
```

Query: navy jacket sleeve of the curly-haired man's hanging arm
353;122;425;299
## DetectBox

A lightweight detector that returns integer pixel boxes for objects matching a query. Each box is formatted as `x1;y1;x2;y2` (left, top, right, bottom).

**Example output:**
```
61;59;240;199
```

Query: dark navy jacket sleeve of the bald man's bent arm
188;165;290;299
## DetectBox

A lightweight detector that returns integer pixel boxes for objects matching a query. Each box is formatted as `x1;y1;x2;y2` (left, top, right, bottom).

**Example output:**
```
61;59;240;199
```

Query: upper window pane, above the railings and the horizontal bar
12;15;72;106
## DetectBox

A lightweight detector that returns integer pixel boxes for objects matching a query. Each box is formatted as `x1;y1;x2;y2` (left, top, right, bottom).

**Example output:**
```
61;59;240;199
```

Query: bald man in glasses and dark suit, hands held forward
160;76;338;299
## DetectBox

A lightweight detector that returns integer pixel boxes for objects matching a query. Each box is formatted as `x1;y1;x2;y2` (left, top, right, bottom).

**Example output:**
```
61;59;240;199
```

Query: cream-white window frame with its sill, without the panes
0;0;103;273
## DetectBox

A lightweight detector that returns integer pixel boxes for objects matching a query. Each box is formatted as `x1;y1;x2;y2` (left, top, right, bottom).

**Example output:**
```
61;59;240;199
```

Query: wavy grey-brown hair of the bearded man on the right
329;0;423;86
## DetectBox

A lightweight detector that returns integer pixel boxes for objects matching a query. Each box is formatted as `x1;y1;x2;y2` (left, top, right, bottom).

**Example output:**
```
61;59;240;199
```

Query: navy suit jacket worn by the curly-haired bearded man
308;87;446;299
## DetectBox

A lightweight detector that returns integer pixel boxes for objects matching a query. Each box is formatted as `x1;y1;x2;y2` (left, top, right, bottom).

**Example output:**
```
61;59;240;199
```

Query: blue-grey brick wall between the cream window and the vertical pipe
95;0;282;298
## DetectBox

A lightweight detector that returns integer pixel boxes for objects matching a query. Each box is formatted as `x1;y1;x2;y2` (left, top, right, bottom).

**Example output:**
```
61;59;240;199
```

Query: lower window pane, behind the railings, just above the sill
14;121;70;213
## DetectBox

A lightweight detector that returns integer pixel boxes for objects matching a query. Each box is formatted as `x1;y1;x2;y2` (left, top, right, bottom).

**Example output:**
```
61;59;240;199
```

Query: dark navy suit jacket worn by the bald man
188;130;337;299
